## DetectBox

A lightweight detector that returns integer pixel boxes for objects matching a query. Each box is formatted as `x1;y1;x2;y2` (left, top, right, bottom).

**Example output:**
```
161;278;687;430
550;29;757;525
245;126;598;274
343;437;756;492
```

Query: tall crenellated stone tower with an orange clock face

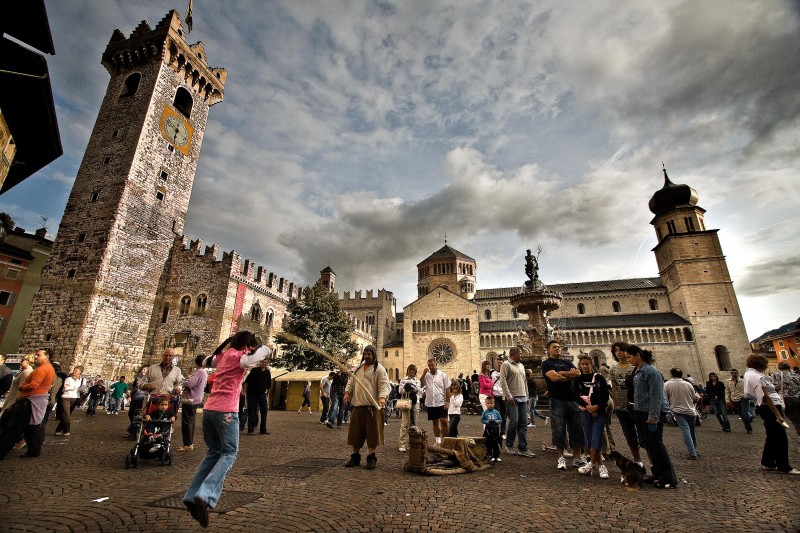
20;11;227;375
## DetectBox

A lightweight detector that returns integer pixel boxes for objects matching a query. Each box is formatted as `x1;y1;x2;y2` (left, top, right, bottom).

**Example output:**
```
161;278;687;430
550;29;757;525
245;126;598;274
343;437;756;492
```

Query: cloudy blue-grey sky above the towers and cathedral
0;0;800;338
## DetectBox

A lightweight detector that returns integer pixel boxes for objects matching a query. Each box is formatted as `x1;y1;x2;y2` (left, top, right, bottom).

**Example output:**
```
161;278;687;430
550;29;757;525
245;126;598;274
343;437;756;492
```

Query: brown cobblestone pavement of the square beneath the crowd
0;411;800;533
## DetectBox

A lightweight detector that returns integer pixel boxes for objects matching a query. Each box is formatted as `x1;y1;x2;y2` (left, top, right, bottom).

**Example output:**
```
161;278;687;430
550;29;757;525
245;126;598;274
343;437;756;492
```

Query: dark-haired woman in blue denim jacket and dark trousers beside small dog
625;345;678;489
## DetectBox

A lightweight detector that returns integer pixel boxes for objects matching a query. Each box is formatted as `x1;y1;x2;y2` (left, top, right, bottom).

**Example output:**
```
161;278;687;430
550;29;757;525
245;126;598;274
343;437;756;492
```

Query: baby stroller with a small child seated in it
125;394;180;468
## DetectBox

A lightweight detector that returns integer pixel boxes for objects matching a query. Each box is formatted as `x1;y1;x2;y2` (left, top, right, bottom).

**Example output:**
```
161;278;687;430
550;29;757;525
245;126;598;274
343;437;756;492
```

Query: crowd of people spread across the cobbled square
0;332;800;526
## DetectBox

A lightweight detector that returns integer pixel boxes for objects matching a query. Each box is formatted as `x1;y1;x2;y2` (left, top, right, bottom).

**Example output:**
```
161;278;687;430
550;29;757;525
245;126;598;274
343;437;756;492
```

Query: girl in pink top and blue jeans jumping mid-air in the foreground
183;331;273;527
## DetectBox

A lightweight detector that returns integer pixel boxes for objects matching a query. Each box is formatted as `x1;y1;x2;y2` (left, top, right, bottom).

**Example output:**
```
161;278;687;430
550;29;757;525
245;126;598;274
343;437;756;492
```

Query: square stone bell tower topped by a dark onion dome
649;169;750;375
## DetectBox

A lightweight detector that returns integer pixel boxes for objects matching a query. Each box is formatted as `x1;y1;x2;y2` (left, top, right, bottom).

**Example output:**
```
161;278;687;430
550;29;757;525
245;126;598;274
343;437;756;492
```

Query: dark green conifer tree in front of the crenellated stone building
275;283;358;370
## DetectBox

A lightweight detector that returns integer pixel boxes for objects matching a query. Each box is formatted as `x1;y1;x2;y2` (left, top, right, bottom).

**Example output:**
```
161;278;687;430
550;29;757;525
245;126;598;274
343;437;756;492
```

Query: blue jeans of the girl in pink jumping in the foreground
183;409;239;507
